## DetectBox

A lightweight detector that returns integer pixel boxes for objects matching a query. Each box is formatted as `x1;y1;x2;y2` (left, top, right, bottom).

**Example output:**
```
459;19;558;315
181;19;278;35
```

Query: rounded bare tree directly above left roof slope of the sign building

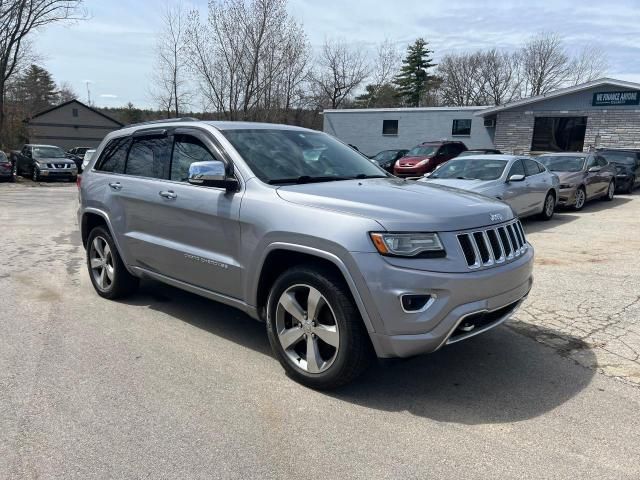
520;33;571;96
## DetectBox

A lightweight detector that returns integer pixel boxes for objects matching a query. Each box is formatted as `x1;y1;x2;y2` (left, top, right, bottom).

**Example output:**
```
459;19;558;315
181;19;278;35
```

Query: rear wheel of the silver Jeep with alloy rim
87;227;139;300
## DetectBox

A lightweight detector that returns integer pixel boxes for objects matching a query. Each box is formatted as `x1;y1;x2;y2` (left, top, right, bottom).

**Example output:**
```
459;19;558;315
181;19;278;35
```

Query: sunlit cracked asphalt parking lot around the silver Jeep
0;181;640;479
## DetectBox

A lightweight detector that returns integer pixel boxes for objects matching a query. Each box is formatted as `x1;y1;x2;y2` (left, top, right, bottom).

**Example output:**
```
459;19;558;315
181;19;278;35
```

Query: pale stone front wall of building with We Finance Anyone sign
494;110;640;153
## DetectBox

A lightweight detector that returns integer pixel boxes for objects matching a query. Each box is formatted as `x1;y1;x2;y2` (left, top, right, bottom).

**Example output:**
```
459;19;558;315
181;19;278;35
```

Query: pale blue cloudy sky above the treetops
34;0;640;107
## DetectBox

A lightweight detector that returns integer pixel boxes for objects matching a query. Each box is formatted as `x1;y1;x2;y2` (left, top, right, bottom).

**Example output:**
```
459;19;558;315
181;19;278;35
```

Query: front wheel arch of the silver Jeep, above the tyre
252;243;375;333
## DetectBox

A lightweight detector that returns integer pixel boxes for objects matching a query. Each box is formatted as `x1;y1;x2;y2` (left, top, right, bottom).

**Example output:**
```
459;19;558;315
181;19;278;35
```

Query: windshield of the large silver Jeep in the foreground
222;129;389;184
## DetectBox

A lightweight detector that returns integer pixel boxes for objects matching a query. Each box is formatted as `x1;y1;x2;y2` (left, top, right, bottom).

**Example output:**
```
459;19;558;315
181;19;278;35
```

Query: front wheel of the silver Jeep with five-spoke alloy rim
267;267;372;389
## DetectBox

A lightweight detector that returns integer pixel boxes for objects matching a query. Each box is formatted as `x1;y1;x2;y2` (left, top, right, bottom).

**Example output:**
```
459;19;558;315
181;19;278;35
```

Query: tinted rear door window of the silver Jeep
125;137;171;179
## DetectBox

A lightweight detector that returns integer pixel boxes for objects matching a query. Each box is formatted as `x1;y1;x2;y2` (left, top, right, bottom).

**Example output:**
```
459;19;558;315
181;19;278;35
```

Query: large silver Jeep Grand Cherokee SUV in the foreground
78;119;533;388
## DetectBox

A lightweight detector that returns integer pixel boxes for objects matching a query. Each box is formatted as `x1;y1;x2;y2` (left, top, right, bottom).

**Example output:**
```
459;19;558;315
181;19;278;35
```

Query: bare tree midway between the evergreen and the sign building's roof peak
480;48;522;105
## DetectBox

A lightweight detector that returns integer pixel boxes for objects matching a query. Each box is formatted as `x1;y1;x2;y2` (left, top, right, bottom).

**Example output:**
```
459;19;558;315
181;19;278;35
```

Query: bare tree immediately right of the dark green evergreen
437;52;484;107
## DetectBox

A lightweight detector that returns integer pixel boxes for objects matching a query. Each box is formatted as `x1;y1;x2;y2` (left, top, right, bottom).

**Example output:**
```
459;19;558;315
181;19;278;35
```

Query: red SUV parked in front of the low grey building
393;141;467;177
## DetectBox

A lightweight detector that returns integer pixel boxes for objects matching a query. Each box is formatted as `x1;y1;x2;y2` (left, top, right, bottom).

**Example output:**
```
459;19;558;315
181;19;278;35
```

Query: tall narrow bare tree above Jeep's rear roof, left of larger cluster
151;3;191;117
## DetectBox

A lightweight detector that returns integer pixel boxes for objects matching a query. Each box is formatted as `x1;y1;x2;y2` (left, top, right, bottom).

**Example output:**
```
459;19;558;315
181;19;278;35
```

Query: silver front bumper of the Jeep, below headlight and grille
353;246;533;358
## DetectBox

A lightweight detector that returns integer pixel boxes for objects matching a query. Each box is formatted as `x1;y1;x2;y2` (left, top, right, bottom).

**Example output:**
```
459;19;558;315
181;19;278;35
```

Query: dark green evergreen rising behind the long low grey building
394;38;436;107
